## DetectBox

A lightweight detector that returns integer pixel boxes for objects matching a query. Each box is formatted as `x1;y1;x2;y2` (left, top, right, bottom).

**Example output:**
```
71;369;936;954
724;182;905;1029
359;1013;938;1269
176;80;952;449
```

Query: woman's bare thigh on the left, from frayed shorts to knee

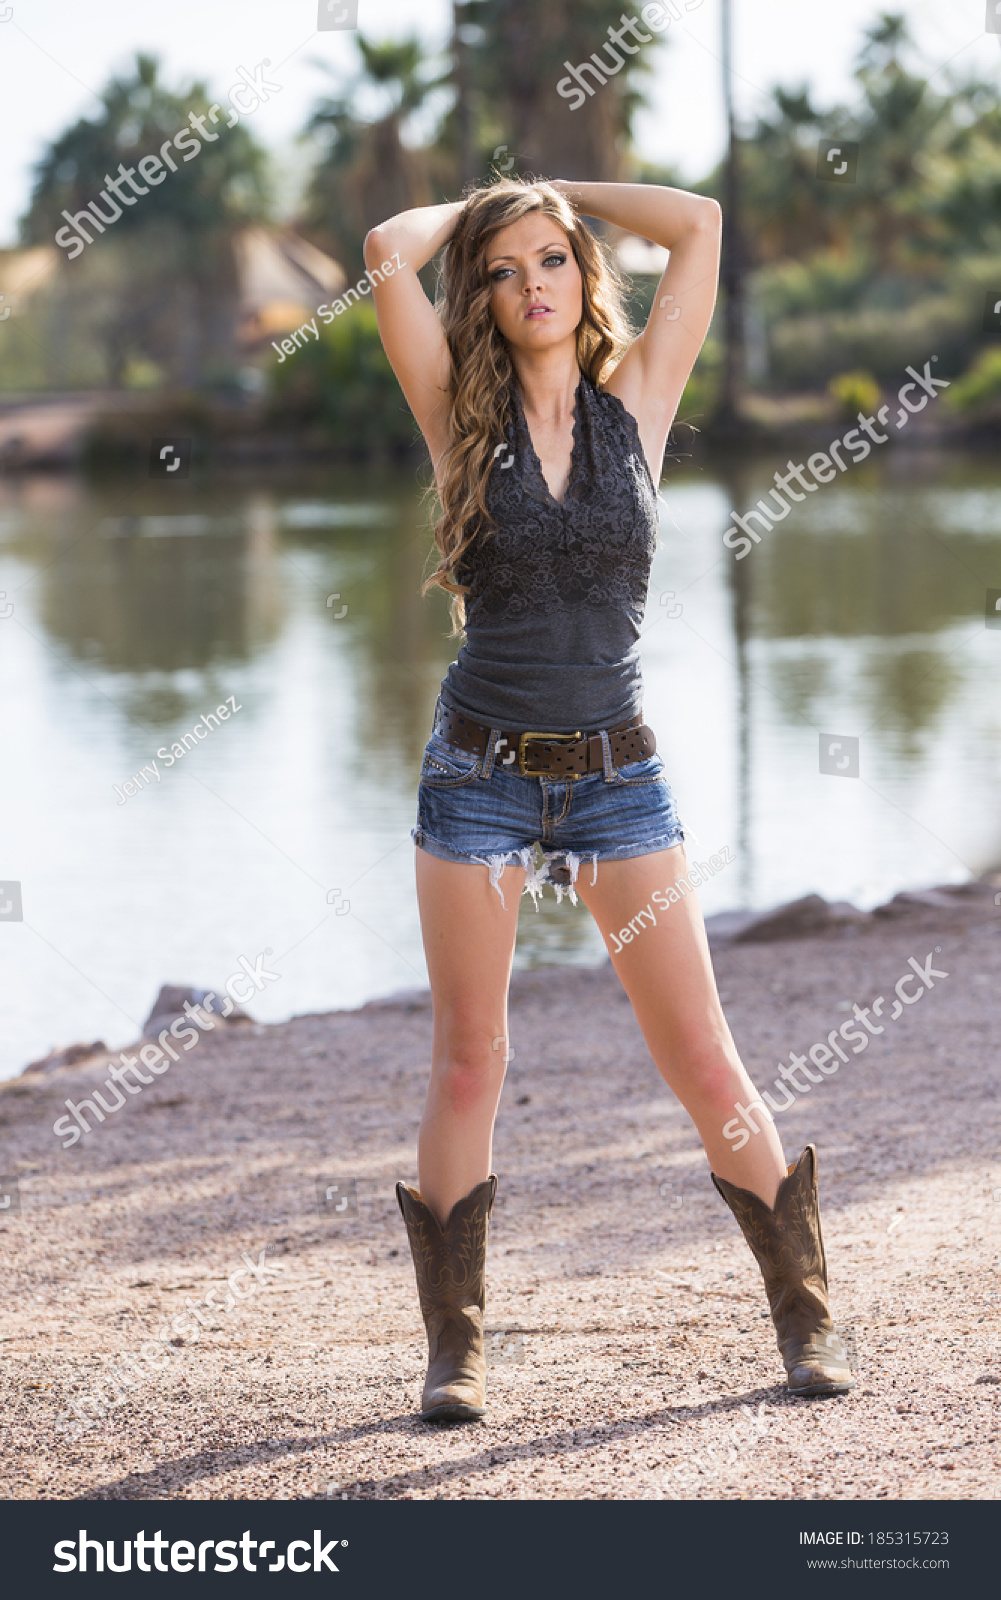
416;848;524;1062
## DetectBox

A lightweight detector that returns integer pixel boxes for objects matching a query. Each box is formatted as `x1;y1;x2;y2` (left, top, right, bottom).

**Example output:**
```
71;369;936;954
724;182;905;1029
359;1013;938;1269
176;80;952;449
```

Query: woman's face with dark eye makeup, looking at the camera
486;211;584;350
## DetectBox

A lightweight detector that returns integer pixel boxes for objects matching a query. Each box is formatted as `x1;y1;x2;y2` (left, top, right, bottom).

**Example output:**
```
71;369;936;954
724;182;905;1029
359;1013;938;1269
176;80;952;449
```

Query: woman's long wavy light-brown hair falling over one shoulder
421;178;633;637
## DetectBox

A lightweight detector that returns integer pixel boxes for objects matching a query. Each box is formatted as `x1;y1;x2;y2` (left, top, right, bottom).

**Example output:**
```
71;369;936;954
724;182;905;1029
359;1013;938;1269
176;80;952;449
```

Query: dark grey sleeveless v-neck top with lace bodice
441;373;660;733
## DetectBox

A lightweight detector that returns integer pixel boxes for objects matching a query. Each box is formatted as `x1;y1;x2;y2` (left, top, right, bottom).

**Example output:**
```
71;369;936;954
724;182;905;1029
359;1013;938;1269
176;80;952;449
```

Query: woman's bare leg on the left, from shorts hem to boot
416;848;524;1222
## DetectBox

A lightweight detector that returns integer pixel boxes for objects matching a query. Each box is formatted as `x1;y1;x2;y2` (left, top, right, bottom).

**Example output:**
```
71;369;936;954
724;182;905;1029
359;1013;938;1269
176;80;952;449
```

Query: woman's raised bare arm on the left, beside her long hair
365;200;465;467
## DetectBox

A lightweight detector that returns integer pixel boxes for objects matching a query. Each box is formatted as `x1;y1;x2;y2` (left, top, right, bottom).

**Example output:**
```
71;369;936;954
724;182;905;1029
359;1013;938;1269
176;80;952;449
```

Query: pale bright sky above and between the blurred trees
0;0;1001;245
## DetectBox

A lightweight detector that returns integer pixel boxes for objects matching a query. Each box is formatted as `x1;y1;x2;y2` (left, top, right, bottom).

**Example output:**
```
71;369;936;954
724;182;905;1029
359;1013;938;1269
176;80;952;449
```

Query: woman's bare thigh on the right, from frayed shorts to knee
577;845;739;1101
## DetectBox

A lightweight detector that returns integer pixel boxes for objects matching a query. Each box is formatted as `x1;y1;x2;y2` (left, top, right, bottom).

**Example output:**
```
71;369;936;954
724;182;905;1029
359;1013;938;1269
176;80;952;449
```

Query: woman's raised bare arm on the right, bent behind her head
555;179;723;483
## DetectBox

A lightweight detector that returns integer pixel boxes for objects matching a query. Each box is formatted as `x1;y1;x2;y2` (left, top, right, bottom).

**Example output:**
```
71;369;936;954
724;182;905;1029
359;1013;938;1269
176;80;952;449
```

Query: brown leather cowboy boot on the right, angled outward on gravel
712;1144;855;1395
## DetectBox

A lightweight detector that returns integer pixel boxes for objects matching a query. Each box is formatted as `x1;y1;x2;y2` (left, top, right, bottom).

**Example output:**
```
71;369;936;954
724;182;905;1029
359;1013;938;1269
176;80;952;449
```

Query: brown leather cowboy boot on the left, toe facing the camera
397;1173;497;1422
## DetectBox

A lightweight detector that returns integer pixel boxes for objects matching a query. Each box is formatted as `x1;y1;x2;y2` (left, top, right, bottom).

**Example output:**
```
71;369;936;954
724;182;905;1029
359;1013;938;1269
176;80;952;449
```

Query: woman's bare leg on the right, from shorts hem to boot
577;845;785;1206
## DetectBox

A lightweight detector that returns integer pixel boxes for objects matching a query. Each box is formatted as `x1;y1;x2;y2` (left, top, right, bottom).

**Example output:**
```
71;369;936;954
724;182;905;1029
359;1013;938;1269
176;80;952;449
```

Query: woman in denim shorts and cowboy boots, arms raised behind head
365;178;852;1421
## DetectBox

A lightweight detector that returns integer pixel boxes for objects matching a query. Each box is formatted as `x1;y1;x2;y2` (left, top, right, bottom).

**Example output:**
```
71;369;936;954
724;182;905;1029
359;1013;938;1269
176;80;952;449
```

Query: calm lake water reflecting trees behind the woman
0;448;1001;1077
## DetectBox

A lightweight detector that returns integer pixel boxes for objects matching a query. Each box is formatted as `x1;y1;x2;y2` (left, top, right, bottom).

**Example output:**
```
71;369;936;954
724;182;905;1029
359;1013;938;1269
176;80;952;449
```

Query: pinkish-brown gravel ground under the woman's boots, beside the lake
0;885;1001;1499
